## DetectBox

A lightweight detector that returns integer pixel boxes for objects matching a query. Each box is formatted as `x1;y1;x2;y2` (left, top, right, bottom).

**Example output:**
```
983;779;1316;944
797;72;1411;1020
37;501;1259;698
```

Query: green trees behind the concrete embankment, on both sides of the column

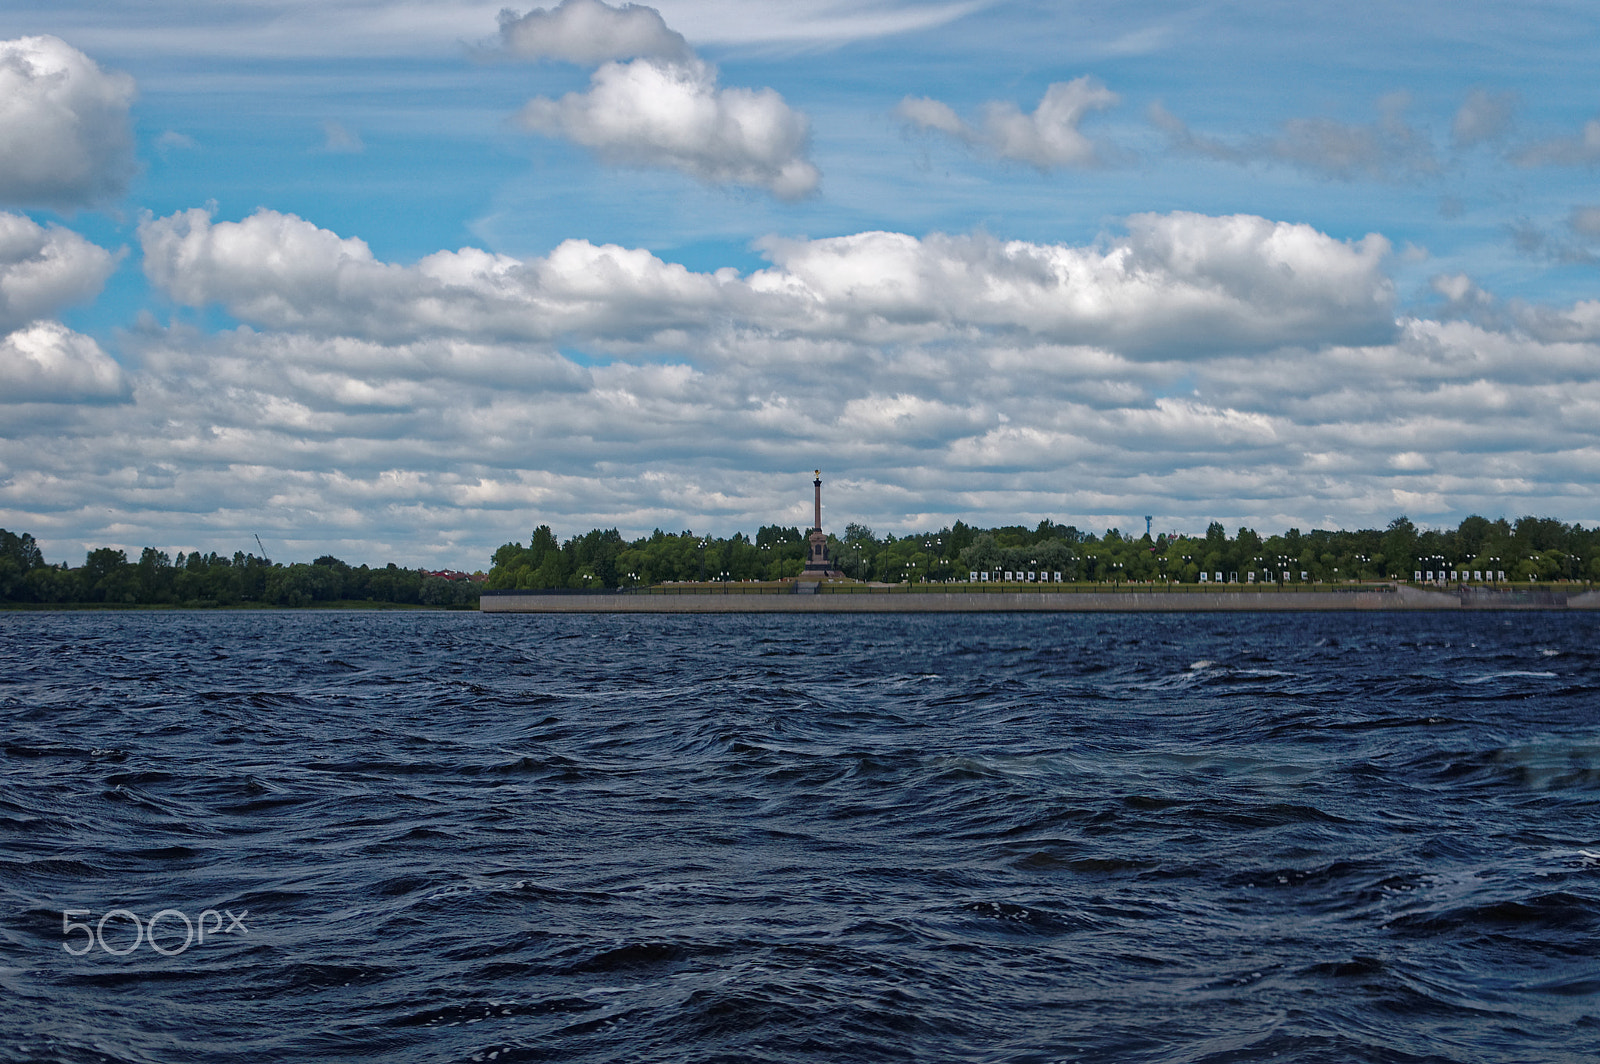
485;515;1600;589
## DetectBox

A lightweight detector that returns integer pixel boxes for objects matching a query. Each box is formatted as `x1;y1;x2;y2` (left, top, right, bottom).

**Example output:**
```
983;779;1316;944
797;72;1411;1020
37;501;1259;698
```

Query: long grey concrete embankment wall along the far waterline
478;586;1600;613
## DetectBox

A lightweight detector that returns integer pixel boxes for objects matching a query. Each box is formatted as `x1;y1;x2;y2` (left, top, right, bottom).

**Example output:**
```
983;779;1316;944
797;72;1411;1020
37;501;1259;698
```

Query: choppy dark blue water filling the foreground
0;613;1600;1062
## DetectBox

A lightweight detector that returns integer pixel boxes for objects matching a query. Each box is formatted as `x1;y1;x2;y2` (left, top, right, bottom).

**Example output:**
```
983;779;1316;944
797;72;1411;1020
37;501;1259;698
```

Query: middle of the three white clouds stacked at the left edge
0;211;117;333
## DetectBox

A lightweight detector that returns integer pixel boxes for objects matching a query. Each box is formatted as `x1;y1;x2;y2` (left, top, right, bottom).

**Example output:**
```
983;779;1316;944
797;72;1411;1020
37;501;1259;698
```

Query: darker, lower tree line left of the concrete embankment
0;528;480;608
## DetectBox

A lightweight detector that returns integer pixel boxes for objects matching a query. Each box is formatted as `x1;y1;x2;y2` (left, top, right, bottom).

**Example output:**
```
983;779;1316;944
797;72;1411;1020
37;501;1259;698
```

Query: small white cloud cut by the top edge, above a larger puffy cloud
499;0;693;66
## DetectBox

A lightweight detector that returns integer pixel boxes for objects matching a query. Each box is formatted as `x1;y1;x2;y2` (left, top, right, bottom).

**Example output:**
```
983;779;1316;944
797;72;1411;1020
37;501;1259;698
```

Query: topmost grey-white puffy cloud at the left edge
0;37;134;208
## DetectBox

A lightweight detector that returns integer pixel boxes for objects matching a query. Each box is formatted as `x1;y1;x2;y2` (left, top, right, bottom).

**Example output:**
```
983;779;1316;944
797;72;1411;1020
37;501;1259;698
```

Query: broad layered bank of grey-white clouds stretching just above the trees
9;211;1600;566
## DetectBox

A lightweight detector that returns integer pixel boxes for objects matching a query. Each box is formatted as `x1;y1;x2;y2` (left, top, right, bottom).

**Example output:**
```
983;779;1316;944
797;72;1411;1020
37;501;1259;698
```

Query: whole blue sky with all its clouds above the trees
0;0;1600;570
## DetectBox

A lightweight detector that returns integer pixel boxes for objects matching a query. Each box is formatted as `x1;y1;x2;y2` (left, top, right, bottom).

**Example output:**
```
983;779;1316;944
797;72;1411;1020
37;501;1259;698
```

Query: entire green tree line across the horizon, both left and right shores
9;515;1600;608
